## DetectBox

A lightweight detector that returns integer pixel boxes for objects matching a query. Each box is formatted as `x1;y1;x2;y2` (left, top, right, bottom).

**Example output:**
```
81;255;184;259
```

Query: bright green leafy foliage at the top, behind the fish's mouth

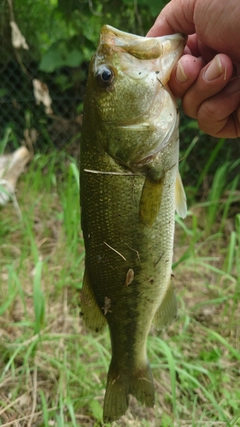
14;0;167;72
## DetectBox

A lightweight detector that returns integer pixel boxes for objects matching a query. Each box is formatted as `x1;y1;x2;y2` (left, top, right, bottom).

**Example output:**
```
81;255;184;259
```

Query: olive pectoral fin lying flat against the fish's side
139;175;165;227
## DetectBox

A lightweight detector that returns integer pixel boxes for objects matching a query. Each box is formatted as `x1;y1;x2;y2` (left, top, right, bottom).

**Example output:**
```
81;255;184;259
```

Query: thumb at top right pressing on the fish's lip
147;0;240;62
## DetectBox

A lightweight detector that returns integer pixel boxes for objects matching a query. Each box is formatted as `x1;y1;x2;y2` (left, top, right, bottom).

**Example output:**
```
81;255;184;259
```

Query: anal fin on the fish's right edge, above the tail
153;280;177;330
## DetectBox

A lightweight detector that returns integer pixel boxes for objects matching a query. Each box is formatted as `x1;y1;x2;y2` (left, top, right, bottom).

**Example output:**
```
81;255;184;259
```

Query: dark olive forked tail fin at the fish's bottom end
103;362;155;423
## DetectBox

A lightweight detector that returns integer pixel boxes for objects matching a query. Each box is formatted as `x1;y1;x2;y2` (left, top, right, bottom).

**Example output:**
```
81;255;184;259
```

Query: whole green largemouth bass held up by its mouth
80;25;187;423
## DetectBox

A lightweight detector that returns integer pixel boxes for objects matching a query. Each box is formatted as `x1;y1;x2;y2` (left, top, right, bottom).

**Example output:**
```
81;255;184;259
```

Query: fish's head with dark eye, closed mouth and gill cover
85;25;186;167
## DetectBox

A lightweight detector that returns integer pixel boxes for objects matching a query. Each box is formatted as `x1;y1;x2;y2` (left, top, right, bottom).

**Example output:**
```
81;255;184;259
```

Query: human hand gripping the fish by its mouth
147;0;240;138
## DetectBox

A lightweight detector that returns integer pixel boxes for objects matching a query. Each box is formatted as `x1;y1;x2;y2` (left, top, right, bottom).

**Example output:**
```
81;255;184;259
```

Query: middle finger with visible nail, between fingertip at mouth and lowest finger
183;54;233;119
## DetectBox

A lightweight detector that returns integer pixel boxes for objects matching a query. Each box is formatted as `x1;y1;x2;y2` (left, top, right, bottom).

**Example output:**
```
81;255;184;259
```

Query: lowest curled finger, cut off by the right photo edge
197;77;240;138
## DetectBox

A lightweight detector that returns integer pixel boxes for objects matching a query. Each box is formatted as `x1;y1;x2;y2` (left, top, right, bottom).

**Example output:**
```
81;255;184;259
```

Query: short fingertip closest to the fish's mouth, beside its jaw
169;55;205;98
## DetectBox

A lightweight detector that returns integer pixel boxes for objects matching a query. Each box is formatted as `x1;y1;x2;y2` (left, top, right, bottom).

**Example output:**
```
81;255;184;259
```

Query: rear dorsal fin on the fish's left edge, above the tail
80;270;107;332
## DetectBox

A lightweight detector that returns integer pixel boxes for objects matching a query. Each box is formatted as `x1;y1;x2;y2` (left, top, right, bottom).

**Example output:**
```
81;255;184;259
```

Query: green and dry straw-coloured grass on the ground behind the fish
0;141;240;427
